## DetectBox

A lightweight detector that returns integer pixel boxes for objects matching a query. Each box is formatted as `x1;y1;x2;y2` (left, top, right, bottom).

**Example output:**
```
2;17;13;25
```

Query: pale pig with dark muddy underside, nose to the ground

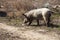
22;8;52;26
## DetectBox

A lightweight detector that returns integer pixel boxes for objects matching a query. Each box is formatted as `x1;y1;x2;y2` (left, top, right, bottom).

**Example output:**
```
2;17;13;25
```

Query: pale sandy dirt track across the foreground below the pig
0;23;60;40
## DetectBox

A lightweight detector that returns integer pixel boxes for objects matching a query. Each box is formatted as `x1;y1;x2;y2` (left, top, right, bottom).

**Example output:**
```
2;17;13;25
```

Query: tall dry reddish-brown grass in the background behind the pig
0;0;60;16
